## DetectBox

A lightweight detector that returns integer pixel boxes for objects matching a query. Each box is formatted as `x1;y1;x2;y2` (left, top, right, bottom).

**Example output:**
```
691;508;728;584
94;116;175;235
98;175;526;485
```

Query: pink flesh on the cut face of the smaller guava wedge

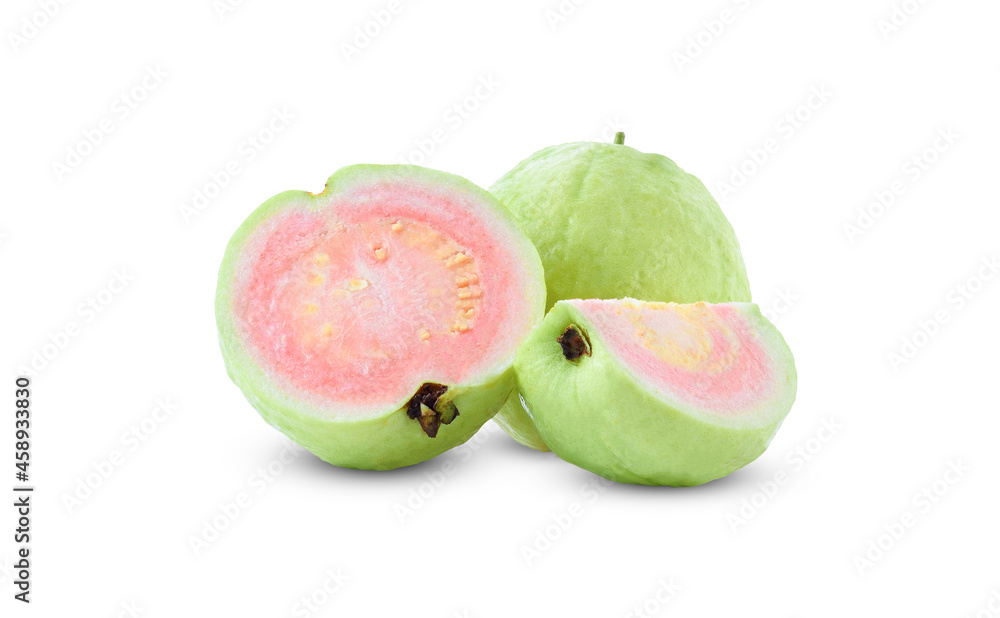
570;300;774;414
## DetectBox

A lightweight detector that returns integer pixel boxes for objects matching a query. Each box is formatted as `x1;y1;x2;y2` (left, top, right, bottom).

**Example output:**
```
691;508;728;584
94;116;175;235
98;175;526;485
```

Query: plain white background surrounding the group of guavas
0;0;1000;618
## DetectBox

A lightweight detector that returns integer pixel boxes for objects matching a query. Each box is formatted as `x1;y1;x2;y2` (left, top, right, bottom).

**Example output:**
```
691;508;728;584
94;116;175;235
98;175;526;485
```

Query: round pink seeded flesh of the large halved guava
233;181;530;408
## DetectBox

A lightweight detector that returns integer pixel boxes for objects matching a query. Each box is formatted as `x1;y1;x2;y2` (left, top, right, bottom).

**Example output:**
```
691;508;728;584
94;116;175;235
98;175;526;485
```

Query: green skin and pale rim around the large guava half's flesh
215;165;545;470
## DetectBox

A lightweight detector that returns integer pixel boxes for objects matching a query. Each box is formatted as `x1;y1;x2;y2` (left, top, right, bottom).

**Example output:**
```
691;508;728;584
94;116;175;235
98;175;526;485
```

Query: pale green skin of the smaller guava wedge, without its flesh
514;303;796;487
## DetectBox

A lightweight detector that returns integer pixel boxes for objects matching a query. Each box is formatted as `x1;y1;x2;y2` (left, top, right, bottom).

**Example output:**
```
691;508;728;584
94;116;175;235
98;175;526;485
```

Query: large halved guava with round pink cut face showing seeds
216;165;545;470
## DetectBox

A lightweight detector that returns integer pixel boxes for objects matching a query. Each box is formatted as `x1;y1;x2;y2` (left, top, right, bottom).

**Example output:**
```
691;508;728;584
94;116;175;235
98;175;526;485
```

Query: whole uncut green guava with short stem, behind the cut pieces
490;133;750;450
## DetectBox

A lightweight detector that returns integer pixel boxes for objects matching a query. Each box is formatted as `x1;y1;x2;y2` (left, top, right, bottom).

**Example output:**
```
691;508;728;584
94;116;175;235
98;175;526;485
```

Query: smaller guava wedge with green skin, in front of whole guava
514;299;796;486
